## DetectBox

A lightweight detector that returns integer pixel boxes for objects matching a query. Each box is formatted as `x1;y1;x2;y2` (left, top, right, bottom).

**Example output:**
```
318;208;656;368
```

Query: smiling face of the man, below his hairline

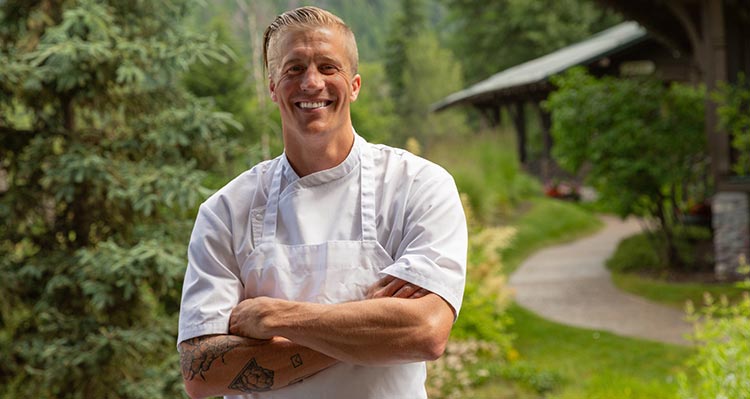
269;27;361;140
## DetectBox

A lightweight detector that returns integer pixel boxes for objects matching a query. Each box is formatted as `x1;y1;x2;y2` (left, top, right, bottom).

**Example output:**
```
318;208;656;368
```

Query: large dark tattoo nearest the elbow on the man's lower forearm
180;337;240;381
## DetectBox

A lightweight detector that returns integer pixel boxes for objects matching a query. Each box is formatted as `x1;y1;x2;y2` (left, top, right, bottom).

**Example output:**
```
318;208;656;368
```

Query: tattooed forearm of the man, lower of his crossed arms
179;335;336;398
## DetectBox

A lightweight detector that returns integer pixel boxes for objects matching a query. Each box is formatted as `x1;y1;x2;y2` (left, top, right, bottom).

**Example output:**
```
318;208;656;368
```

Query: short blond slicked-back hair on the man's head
263;6;359;75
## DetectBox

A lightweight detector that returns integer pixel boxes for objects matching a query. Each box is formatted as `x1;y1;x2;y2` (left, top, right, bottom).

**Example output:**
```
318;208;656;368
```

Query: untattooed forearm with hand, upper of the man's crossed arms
238;294;453;365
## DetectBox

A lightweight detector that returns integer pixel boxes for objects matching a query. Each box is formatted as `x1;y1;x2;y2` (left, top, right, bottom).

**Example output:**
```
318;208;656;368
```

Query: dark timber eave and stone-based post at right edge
597;0;750;277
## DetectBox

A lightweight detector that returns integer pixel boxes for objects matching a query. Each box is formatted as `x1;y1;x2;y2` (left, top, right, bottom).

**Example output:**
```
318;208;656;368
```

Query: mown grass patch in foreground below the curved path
470;305;691;399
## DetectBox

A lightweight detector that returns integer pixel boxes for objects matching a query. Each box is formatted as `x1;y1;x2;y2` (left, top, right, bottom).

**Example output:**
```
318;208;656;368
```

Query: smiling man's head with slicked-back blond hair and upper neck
265;7;361;160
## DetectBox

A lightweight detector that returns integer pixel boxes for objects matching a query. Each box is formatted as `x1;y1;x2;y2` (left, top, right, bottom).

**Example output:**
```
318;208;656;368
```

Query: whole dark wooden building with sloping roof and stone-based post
434;0;750;277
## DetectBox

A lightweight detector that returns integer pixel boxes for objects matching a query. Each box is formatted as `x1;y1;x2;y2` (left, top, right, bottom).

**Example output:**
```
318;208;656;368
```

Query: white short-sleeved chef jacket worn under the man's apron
178;134;467;397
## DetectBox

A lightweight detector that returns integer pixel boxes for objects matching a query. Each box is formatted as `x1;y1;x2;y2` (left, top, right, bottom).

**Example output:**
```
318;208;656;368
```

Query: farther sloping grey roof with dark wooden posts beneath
433;22;696;181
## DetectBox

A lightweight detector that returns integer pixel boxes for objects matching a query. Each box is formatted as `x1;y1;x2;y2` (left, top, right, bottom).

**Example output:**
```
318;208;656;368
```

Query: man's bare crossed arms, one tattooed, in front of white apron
179;276;454;398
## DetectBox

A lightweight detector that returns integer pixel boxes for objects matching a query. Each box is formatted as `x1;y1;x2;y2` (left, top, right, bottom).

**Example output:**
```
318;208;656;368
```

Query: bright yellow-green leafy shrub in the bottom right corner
680;292;750;399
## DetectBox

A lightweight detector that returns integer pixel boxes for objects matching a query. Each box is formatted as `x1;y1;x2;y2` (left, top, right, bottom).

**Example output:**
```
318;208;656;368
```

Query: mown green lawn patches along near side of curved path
466;198;691;399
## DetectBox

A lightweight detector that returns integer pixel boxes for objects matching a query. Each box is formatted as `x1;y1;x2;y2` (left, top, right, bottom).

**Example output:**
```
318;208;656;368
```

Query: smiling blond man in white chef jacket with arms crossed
178;7;467;399
